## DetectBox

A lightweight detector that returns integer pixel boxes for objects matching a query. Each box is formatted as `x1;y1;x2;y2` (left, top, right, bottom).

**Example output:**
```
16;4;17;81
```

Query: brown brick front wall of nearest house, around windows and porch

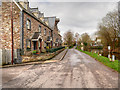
24;13;51;51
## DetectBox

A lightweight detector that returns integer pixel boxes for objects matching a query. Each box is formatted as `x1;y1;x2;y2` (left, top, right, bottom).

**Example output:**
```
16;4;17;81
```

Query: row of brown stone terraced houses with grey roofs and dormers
0;1;62;63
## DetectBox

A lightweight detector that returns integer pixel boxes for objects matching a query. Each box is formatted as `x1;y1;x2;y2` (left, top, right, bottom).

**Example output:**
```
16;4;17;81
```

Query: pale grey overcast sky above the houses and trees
29;0;117;38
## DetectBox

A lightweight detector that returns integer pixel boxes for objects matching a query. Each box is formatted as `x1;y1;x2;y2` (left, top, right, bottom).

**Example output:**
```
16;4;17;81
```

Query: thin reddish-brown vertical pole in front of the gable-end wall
11;0;14;64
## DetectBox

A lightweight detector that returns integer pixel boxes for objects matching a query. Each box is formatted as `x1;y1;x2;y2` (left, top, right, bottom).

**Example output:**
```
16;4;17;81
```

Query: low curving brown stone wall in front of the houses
22;49;64;63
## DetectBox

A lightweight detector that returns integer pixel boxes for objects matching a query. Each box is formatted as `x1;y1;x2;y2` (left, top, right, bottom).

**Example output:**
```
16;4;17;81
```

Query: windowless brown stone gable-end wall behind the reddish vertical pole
0;2;20;49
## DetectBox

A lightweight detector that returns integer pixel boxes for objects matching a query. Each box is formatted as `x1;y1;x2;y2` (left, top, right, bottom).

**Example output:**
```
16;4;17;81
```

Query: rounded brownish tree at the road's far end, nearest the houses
63;30;74;47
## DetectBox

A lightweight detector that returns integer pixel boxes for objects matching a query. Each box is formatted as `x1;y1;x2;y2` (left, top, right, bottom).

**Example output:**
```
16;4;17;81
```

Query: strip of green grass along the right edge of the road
77;49;120;73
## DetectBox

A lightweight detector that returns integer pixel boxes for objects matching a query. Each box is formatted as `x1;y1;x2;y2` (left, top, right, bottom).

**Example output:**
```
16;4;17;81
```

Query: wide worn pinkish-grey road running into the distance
3;49;118;88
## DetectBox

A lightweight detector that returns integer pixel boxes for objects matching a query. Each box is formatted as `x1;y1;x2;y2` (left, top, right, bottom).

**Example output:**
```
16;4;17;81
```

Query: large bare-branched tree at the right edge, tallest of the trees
98;10;120;50
